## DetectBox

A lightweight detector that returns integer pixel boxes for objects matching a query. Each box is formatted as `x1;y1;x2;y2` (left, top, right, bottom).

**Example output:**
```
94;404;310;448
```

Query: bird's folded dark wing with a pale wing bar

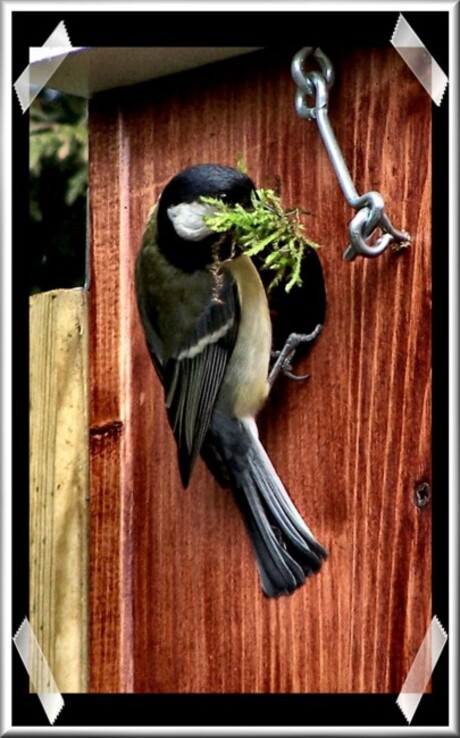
163;270;239;487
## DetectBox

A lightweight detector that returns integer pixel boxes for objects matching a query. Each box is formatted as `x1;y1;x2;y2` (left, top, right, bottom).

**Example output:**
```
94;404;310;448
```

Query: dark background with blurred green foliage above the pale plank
29;90;88;293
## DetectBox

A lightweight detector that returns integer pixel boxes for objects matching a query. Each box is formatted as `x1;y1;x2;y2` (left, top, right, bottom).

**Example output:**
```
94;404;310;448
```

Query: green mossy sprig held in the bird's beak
201;188;318;292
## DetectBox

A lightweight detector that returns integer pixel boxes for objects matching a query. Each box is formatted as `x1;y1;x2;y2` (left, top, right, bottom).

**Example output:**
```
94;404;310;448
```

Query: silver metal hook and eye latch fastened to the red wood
291;46;410;261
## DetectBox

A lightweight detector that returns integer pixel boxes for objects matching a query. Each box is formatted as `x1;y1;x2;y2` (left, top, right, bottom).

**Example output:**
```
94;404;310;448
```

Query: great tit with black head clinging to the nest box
136;164;327;597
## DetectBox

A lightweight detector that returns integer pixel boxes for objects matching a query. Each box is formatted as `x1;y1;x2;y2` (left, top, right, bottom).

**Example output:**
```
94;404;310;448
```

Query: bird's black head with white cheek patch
157;164;254;271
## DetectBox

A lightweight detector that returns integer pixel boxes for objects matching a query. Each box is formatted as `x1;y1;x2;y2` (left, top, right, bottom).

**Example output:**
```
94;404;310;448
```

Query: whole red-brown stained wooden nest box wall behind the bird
90;49;431;692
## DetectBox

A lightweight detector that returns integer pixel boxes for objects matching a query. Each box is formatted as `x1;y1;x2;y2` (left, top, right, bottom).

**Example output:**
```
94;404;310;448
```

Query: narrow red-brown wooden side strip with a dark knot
89;107;132;692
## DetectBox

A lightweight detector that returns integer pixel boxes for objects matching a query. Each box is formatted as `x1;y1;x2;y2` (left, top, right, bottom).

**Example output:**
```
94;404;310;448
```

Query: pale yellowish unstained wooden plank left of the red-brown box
29;290;88;692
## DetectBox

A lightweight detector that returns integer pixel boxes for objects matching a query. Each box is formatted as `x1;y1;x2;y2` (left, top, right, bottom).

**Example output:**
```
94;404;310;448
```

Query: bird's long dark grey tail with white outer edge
205;415;327;597
